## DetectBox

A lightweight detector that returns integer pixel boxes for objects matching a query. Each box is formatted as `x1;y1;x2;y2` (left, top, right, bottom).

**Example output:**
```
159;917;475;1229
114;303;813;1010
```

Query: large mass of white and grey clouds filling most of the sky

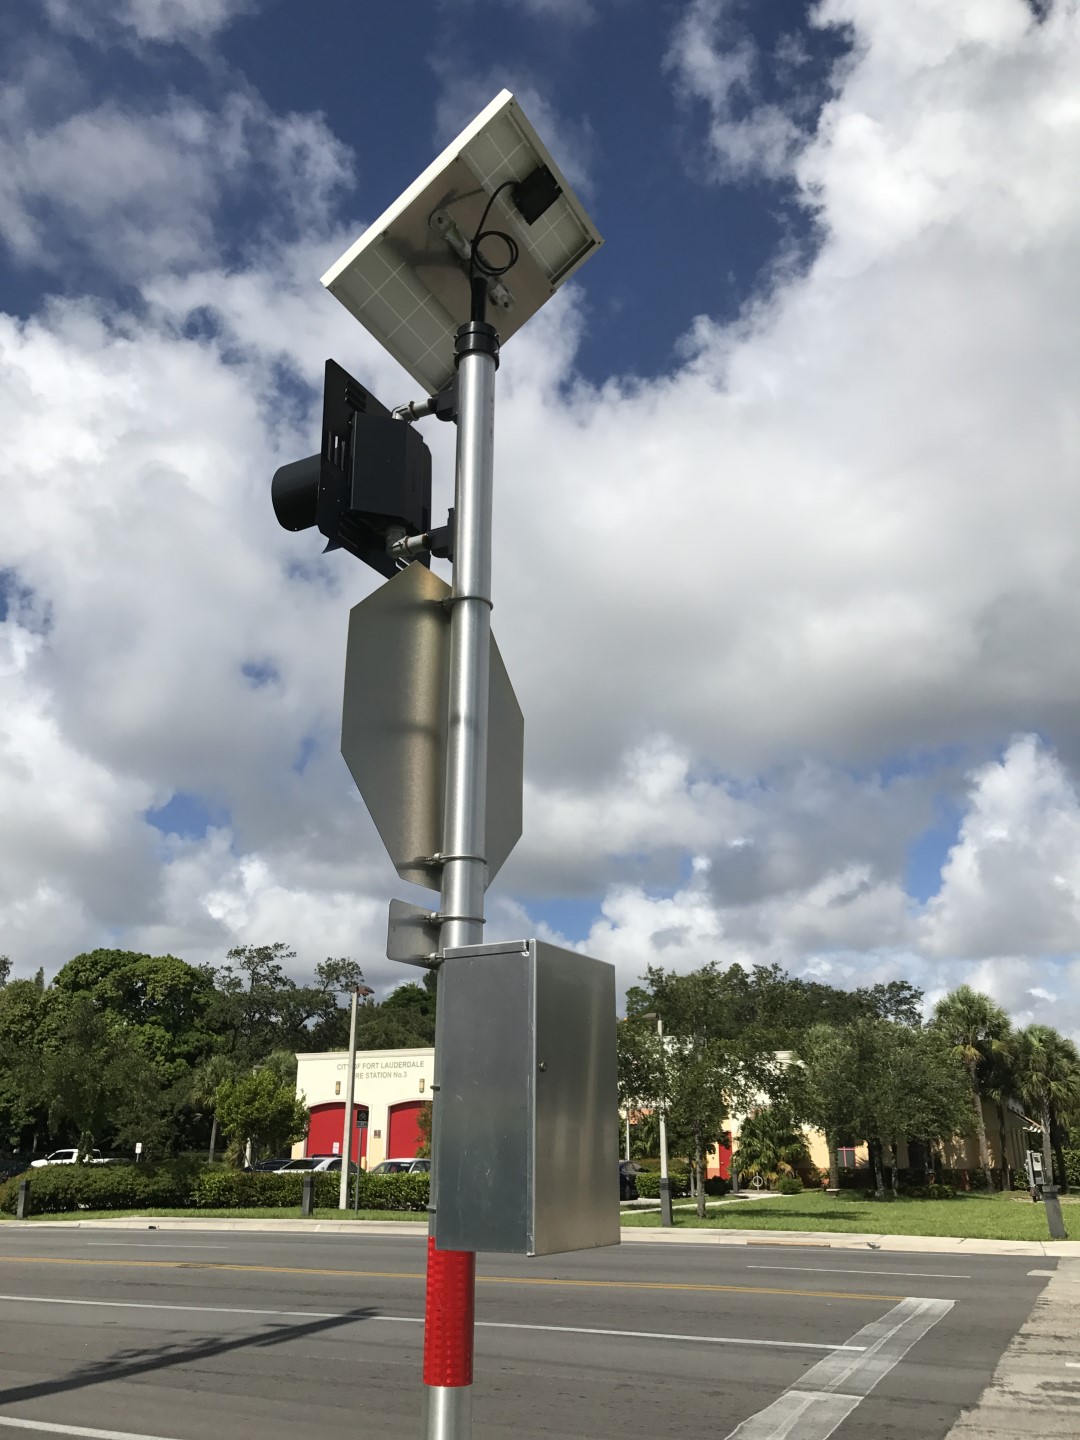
0;0;1080;1025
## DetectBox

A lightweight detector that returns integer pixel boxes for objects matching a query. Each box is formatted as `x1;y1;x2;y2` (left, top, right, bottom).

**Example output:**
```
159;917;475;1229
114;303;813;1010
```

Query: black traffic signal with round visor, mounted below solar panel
271;360;431;576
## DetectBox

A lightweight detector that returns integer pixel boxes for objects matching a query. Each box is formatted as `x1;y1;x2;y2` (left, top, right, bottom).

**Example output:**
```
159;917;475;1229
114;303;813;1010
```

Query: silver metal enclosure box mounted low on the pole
432;940;619;1256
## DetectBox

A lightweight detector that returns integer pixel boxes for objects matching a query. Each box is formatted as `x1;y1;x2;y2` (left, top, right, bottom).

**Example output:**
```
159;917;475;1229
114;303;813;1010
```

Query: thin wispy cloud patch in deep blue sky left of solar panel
0;80;350;281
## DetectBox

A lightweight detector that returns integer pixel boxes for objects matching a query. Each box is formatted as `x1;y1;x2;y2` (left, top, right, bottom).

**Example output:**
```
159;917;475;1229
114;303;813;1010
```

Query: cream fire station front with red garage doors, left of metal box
292;1048;435;1169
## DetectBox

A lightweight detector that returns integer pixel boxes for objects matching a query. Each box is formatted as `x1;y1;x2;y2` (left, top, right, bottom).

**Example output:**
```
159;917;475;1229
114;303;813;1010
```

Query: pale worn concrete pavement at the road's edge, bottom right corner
948;1260;1080;1440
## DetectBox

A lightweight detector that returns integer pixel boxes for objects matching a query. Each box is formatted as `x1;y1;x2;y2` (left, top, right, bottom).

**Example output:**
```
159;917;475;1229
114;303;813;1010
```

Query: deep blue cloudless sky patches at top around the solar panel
0;0;847;382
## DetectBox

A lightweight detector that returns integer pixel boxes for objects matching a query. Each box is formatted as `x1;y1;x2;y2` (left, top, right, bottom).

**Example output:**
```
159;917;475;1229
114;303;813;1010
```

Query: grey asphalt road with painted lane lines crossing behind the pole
0;1227;1057;1440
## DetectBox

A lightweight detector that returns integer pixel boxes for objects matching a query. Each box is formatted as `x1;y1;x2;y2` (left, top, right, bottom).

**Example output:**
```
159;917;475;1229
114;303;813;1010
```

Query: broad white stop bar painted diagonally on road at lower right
727;1297;953;1440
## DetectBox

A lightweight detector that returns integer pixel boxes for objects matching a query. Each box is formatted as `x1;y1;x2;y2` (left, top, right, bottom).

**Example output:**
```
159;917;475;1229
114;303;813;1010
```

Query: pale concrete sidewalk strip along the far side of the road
0;1215;1080;1255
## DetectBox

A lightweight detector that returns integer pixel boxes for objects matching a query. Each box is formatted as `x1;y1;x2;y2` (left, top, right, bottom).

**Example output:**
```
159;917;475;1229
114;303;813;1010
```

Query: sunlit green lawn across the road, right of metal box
622;1191;1080;1240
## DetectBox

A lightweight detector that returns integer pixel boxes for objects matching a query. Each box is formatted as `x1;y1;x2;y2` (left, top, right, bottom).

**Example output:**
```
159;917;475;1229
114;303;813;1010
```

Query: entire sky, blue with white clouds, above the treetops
0;0;1080;1025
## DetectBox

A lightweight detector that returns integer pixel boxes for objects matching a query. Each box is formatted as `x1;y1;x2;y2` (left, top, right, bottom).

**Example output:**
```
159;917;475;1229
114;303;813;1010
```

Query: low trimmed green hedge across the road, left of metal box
0;1161;429;1215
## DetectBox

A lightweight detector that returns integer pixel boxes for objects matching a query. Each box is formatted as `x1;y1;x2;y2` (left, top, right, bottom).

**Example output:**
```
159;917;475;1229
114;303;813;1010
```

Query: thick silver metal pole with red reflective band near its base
423;320;498;1440
